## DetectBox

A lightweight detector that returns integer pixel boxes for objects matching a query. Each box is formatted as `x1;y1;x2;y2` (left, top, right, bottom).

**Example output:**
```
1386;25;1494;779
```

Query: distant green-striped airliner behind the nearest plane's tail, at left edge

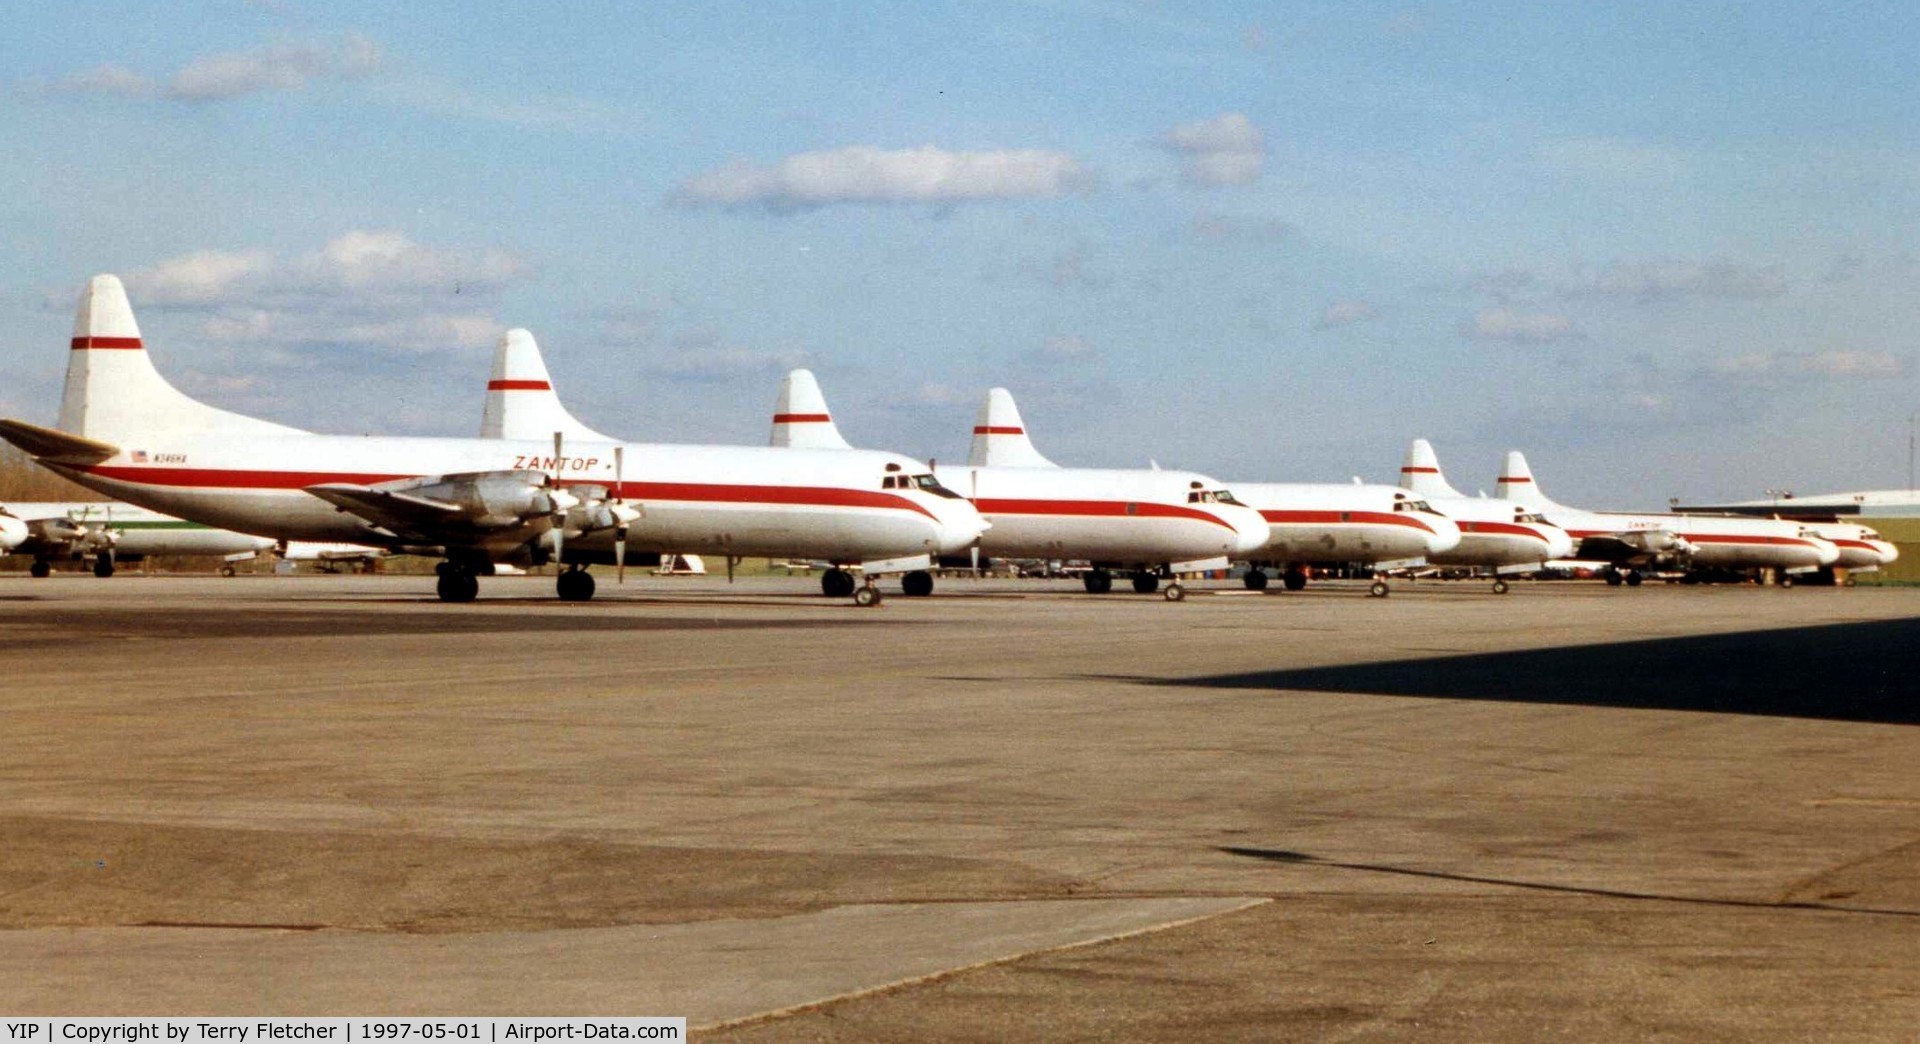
0;501;275;576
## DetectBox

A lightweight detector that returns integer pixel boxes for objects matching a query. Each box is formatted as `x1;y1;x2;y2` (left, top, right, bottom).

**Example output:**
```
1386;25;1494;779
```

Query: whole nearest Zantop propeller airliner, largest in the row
0;274;981;605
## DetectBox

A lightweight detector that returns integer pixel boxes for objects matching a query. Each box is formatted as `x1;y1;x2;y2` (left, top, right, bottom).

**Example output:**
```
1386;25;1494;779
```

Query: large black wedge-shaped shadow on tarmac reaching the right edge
1142;618;1920;725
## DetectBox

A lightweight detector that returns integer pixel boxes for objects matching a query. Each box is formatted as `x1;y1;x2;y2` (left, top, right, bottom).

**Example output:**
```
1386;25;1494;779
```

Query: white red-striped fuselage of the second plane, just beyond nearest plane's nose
935;466;1260;564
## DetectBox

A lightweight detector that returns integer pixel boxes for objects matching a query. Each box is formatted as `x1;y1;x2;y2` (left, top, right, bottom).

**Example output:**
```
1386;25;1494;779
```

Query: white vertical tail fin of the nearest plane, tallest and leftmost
58;274;298;443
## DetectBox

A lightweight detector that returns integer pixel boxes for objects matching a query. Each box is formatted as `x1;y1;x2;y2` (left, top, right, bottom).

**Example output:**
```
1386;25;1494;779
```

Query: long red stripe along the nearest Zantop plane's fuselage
83;464;939;522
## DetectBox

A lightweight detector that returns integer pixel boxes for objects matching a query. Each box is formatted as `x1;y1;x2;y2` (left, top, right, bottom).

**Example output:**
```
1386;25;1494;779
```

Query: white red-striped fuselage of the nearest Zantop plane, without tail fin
63;434;972;560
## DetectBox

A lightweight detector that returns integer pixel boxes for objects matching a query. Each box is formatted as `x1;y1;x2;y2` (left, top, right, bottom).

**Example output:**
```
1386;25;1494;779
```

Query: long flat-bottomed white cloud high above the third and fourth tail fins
674;146;1092;207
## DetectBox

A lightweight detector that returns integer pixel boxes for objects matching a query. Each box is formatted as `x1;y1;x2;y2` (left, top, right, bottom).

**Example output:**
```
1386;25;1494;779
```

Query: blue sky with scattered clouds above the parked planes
0;0;1920;507
